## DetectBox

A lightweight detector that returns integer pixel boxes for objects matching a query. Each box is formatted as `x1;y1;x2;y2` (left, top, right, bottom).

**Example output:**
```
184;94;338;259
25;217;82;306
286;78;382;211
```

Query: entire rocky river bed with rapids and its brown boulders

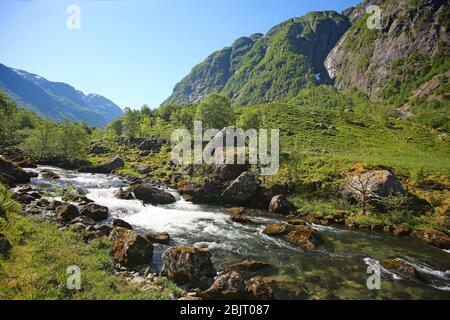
3;167;450;299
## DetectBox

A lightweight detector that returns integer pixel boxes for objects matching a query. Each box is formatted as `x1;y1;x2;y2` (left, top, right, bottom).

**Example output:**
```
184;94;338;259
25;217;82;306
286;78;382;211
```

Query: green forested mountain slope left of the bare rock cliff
164;11;350;105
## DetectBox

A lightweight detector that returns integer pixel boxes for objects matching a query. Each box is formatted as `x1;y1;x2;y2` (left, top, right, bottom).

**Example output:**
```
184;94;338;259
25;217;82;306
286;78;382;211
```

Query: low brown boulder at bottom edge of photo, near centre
199;271;250;300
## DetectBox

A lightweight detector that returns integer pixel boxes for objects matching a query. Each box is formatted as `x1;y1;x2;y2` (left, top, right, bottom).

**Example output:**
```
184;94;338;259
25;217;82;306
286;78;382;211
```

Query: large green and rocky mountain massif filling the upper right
163;0;450;105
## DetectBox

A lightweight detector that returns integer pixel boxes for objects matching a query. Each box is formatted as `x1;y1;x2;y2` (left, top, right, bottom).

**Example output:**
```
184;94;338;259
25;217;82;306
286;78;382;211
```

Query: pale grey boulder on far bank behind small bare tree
344;170;406;202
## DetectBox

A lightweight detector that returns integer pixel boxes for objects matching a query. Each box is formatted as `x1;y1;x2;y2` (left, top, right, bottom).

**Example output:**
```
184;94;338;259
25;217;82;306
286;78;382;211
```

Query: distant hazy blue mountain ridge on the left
0;64;123;127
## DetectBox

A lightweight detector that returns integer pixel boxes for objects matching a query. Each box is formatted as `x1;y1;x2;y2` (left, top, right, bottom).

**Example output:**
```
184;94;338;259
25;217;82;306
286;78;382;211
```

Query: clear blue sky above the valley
0;0;360;107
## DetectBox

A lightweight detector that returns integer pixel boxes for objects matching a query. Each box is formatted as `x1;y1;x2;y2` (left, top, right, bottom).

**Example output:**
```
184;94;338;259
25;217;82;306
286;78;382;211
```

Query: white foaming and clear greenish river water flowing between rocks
25;167;450;299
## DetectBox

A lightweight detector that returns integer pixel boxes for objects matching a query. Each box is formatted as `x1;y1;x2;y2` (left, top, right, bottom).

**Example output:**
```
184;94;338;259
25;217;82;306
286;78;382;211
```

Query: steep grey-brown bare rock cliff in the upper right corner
325;0;450;99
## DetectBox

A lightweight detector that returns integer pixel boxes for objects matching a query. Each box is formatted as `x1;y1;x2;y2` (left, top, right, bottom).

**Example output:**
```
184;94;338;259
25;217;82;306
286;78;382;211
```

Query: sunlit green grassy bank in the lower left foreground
0;192;180;300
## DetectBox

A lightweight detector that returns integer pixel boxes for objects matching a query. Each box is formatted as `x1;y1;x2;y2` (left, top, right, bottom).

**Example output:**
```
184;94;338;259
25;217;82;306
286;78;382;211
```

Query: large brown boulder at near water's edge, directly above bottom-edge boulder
161;246;216;289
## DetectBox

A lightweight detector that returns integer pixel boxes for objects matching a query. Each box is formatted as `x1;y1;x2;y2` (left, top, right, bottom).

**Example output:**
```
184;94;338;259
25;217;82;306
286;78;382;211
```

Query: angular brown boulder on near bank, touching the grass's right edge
109;228;153;267
